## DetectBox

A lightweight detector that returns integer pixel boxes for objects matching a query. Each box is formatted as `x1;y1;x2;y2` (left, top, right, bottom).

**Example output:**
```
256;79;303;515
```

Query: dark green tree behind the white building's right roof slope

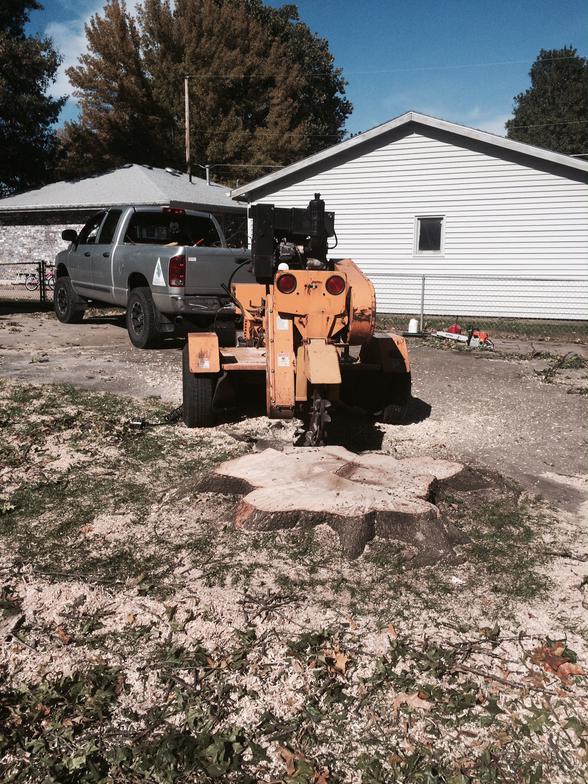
506;46;588;155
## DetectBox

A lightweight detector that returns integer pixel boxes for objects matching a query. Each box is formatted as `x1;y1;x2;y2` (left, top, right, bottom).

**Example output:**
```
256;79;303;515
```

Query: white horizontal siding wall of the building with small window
250;133;588;319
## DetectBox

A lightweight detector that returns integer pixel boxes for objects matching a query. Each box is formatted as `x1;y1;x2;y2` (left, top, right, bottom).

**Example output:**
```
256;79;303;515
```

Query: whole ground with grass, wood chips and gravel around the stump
0;308;588;784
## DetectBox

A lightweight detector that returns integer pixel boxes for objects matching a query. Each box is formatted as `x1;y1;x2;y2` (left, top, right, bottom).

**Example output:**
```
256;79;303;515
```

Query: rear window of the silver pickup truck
125;212;221;247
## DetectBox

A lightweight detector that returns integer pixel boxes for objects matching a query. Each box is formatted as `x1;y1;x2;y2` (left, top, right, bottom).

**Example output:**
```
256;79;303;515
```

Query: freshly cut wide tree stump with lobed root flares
204;446;466;563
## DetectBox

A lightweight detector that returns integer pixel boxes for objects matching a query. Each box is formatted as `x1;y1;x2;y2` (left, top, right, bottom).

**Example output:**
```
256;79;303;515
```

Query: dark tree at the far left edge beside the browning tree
0;0;65;196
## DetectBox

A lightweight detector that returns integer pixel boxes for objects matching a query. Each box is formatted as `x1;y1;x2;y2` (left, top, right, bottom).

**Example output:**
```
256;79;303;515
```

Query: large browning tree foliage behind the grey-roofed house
57;0;351;181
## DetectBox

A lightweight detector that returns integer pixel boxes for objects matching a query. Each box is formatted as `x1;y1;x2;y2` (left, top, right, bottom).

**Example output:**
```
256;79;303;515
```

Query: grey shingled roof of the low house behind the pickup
0;163;244;213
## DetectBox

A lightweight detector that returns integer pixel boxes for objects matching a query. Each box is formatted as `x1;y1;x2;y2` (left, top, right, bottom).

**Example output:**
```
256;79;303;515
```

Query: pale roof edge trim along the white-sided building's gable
231;112;588;201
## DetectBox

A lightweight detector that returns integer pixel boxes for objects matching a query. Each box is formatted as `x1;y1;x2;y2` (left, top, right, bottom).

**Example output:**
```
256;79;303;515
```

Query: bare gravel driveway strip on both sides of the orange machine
0;304;588;510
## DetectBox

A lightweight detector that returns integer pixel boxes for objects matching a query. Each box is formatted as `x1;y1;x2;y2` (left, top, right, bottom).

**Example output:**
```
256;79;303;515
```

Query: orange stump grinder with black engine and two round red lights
183;194;410;446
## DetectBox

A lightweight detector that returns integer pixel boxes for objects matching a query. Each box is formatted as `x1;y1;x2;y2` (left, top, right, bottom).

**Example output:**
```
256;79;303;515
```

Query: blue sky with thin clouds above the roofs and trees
31;0;588;134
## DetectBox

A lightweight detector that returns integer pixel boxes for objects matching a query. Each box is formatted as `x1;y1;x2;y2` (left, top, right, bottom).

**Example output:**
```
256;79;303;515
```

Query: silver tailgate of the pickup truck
185;247;254;295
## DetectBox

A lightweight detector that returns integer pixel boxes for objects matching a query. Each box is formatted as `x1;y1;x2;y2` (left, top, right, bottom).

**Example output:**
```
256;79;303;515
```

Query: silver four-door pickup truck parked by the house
54;206;254;348
